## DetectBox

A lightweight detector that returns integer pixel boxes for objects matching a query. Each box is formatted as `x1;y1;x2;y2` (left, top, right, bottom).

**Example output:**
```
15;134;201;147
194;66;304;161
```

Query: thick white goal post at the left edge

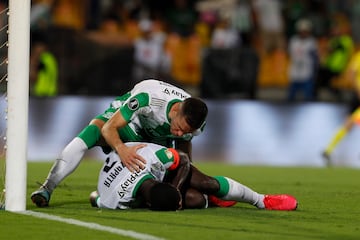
5;0;31;211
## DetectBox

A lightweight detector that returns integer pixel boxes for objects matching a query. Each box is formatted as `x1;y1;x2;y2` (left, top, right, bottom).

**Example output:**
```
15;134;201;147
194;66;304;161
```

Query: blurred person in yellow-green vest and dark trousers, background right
315;24;354;100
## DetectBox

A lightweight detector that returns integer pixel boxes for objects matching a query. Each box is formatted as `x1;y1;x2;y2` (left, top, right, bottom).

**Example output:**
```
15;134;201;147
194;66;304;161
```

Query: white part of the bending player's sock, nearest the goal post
44;137;88;192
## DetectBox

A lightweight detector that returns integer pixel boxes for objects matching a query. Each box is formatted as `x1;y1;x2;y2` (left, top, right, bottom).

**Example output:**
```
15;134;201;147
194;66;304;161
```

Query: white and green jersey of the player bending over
112;79;193;145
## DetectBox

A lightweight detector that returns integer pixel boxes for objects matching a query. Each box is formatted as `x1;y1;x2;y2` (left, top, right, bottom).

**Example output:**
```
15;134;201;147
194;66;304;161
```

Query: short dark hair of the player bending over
181;97;208;129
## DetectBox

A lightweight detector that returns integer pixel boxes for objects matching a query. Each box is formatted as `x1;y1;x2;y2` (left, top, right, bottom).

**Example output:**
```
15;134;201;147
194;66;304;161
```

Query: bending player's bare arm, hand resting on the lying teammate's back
101;110;146;172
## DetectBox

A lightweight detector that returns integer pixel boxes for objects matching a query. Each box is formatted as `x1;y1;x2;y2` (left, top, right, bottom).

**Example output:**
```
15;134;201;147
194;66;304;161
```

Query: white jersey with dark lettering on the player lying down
97;142;179;209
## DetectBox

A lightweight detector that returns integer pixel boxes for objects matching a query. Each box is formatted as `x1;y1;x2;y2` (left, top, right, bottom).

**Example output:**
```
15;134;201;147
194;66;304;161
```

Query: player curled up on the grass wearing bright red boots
90;143;297;210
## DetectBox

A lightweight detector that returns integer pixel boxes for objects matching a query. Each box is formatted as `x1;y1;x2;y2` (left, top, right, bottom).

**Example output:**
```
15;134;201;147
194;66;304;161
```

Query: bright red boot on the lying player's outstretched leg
264;194;298;211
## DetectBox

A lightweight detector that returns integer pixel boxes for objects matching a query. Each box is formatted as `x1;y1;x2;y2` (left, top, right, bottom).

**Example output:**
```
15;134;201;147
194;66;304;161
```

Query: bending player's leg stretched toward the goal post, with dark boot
31;119;105;207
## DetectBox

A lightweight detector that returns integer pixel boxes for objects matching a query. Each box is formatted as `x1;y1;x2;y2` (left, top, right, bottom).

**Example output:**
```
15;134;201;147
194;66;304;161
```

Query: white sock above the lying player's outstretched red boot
222;177;265;208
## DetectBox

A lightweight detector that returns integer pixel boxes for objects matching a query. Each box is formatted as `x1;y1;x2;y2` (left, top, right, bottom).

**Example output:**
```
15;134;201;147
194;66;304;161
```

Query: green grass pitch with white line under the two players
0;161;360;240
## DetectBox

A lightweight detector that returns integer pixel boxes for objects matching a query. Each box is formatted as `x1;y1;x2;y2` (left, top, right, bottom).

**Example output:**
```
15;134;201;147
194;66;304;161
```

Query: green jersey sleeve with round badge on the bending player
120;93;150;122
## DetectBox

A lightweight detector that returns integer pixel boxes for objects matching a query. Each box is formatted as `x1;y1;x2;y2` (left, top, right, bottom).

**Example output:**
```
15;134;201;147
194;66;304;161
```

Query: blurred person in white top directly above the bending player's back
133;19;171;83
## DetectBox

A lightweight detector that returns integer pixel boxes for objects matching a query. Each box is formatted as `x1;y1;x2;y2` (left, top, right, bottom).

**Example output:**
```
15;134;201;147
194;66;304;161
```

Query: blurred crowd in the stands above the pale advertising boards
1;0;360;101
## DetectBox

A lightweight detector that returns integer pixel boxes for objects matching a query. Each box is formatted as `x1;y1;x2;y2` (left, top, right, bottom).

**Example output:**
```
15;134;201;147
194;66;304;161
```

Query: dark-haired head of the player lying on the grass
150;183;181;211
